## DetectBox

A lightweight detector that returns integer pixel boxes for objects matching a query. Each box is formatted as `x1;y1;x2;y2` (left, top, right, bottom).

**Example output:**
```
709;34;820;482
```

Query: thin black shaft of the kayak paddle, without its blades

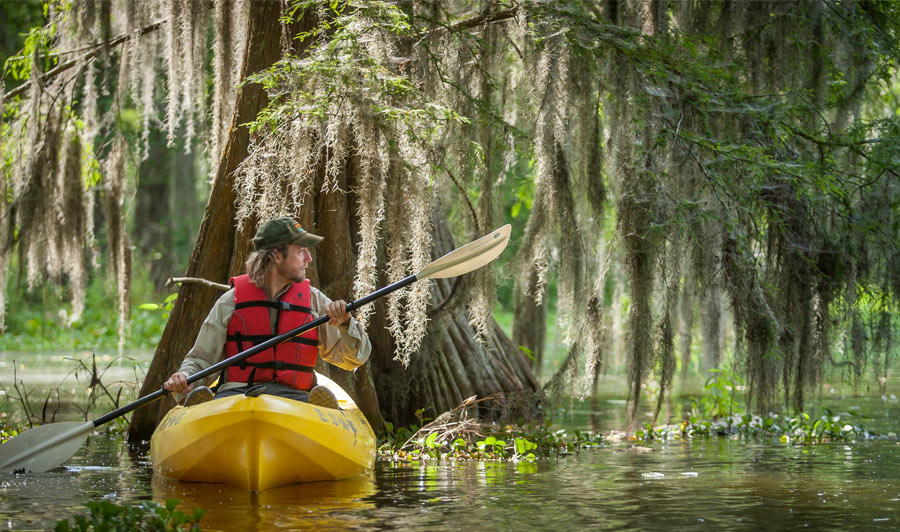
93;274;418;427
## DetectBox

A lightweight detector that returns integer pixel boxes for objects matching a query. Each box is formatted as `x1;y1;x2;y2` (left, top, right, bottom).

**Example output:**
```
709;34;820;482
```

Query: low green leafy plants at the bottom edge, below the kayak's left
54;499;206;532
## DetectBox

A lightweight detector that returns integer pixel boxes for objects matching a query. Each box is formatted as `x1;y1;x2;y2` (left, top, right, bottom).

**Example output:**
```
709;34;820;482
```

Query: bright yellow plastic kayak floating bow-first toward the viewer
150;375;375;491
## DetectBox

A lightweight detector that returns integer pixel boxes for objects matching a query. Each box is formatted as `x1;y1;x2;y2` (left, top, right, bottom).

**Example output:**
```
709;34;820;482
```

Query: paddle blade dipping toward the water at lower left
0;421;94;473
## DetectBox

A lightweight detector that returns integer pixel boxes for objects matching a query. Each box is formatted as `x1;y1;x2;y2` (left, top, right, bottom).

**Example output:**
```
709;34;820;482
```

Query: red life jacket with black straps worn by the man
225;274;319;390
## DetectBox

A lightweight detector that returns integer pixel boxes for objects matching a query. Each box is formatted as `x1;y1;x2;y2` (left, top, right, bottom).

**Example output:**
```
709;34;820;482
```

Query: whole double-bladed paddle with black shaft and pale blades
0;224;512;473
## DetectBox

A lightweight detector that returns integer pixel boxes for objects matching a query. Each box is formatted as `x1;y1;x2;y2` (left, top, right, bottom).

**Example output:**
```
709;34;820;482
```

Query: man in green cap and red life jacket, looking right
163;218;372;408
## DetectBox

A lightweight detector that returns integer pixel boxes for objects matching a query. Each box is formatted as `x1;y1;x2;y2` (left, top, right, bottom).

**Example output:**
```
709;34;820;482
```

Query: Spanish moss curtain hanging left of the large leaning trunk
0;0;245;342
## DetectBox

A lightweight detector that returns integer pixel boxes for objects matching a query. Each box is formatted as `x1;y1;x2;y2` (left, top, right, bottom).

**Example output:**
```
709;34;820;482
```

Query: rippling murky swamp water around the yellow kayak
0;356;900;531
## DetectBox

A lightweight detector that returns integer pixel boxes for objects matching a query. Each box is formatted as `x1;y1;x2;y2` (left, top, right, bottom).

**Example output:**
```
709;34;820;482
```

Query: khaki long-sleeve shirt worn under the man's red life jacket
179;285;372;391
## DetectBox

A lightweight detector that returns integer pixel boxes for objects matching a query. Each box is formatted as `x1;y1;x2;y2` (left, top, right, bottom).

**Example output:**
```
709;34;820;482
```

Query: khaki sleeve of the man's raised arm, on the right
310;287;372;371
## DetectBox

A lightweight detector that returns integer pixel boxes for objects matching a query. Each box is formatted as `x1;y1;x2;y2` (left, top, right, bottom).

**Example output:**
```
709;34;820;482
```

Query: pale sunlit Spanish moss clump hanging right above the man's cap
235;0;443;364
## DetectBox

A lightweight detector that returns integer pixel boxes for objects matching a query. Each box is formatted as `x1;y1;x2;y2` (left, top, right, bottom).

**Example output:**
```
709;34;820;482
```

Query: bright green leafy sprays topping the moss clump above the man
250;0;468;141
